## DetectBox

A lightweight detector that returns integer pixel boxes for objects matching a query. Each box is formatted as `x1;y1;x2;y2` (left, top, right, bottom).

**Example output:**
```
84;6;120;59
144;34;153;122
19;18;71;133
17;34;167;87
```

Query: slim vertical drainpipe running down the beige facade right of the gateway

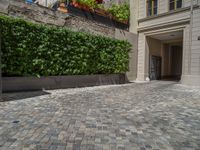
188;0;194;75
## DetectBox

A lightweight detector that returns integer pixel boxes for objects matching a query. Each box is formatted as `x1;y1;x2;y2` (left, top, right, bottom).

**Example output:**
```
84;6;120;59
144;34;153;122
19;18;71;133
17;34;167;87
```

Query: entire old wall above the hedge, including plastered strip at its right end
0;0;137;81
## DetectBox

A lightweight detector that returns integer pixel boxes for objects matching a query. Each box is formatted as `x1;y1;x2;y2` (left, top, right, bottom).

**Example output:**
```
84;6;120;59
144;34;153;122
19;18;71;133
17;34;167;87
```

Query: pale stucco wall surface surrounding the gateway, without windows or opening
134;0;200;85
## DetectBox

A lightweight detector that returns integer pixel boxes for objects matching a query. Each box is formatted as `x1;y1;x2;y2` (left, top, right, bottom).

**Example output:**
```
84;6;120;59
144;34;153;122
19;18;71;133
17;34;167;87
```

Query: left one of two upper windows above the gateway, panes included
147;0;158;16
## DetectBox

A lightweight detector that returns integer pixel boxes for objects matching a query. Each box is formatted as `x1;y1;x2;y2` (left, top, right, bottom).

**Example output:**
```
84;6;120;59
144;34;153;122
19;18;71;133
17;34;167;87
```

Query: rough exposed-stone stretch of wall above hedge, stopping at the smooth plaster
0;0;115;37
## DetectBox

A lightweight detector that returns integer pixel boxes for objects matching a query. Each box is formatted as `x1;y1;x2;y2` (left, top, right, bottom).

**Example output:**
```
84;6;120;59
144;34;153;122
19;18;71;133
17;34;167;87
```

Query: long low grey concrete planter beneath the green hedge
2;74;126;92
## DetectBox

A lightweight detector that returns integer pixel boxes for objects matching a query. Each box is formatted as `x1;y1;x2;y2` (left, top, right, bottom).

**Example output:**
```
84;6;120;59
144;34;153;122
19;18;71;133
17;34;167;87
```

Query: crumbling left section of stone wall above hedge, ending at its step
0;0;69;26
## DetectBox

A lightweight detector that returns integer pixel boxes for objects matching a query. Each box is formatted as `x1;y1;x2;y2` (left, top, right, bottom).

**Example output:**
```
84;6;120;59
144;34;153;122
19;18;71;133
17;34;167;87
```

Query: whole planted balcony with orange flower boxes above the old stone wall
26;0;130;30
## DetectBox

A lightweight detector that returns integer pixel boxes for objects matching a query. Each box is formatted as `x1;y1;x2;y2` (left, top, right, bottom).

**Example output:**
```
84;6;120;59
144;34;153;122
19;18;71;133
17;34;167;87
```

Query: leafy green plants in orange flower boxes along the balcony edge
68;0;130;29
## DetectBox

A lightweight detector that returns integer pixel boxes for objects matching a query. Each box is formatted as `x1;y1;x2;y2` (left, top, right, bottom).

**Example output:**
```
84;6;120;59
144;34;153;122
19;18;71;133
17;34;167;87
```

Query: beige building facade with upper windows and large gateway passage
130;0;200;86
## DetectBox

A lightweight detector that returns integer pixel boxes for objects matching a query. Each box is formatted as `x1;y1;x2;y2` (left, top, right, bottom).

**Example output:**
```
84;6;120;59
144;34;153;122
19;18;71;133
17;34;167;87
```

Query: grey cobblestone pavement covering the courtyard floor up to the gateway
0;81;200;150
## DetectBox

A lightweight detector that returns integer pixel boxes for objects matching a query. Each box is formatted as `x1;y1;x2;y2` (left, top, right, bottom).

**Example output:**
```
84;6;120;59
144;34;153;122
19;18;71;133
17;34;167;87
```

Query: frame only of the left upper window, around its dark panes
146;0;159;17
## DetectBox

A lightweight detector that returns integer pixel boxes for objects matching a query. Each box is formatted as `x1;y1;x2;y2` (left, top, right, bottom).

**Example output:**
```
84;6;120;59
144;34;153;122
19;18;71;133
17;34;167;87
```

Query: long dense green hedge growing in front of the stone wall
0;16;131;76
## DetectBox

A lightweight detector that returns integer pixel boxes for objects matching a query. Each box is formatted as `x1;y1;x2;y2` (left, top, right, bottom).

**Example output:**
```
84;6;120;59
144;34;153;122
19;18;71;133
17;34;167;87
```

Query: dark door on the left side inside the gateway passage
149;56;161;80
